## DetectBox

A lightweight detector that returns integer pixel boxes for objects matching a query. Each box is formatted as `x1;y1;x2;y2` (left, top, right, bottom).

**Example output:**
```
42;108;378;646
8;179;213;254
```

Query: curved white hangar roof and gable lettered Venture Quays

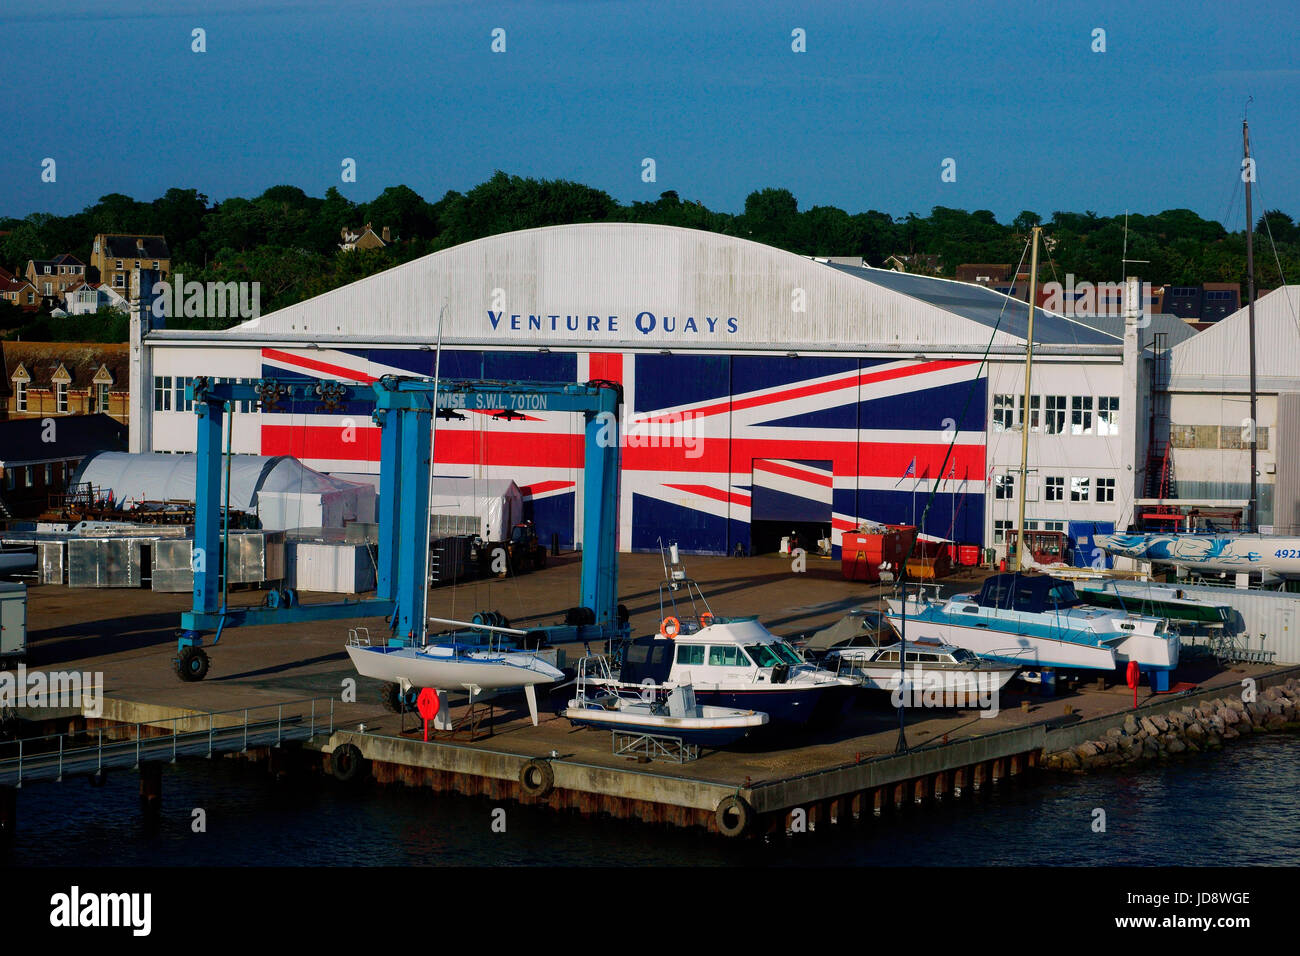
151;222;1122;352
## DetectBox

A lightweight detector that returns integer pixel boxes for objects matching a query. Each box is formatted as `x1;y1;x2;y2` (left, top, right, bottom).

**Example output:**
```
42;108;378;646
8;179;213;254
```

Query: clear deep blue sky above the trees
0;0;1300;228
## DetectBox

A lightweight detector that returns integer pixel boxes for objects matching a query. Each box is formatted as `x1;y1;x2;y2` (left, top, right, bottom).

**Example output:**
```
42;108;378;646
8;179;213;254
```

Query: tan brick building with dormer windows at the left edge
0;342;130;424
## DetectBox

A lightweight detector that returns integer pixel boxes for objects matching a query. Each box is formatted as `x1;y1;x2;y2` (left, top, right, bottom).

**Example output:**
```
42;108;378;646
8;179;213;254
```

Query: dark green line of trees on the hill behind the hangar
0;172;1300;341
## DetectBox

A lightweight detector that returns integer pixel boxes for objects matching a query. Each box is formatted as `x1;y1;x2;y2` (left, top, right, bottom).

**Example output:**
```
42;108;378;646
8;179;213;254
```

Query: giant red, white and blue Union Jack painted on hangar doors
250;347;985;554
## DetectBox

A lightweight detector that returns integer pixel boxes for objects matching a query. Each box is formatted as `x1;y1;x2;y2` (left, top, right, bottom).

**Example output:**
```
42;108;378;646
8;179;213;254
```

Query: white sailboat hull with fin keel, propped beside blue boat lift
346;624;564;728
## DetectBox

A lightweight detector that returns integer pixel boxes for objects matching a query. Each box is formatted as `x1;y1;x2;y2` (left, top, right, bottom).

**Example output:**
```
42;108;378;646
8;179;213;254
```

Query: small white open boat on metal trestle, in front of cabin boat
559;656;767;748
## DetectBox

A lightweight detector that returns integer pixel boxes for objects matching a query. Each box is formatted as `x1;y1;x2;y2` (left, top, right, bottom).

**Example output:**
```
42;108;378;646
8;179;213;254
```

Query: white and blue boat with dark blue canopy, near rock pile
885;574;1179;684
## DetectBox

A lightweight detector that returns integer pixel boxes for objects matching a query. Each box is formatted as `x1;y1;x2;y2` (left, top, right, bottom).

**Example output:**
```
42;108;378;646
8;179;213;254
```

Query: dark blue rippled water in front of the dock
0;735;1300;866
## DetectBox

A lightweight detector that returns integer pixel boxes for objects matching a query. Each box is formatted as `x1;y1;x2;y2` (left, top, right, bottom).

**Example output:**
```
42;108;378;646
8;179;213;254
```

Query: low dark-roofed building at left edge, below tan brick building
0;415;127;519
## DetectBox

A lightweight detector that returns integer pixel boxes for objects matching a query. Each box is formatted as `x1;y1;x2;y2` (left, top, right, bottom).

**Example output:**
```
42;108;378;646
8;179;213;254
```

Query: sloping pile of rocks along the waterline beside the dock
1043;678;1300;771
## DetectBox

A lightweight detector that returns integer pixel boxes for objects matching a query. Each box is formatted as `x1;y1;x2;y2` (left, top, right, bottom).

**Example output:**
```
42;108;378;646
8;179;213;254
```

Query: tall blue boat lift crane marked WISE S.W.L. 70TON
174;376;628;680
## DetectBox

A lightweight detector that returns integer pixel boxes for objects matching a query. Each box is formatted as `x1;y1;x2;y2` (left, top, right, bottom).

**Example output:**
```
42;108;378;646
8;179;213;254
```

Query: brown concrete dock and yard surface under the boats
7;554;1295;834
